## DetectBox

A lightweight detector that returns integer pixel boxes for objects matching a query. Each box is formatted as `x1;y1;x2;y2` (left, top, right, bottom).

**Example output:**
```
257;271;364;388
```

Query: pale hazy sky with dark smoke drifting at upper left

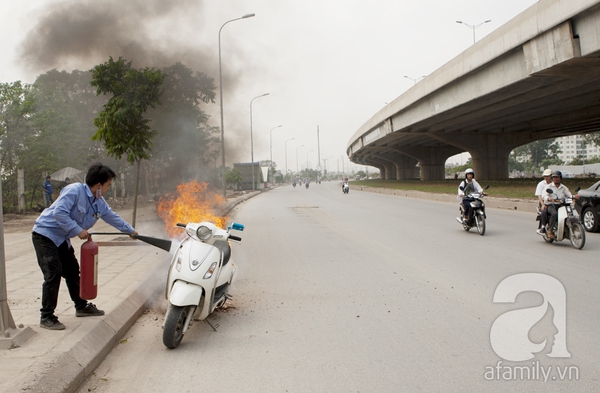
0;0;537;175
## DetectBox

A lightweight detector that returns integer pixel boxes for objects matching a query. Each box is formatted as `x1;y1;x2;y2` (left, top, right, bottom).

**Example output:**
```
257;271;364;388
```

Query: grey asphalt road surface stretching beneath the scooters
80;182;600;392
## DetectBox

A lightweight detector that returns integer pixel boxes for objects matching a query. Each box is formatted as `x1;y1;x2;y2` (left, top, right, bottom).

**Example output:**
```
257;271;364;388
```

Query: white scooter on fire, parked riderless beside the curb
163;222;244;349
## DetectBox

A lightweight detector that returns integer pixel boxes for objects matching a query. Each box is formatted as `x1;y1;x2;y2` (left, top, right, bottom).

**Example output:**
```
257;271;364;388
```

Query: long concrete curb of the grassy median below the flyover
350;184;538;213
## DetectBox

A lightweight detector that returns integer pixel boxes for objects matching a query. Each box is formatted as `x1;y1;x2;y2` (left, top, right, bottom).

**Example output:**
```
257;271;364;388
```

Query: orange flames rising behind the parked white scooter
157;180;227;237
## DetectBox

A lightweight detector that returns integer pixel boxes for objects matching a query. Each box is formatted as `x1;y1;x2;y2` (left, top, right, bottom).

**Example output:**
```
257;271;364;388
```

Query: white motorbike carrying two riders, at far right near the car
536;187;585;250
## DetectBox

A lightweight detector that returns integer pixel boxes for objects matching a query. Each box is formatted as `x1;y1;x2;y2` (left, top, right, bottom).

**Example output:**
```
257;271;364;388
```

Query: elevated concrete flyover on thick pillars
346;0;600;180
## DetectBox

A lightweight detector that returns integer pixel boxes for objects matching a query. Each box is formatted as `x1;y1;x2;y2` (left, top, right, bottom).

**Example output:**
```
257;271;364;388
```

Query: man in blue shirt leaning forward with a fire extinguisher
32;163;137;330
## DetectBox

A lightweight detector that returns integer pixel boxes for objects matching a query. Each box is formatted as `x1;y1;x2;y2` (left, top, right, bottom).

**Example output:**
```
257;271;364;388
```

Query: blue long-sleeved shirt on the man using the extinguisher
33;183;134;247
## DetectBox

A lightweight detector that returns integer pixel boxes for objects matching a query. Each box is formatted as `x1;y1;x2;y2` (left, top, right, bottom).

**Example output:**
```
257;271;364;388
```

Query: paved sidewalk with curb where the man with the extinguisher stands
0;191;255;393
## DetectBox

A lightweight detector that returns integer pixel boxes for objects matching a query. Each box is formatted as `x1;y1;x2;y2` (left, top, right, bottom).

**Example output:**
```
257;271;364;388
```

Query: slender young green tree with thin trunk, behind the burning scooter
91;57;165;226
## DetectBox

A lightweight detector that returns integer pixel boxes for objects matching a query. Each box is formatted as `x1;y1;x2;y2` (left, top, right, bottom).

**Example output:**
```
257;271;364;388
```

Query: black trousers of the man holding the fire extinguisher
31;232;87;318
